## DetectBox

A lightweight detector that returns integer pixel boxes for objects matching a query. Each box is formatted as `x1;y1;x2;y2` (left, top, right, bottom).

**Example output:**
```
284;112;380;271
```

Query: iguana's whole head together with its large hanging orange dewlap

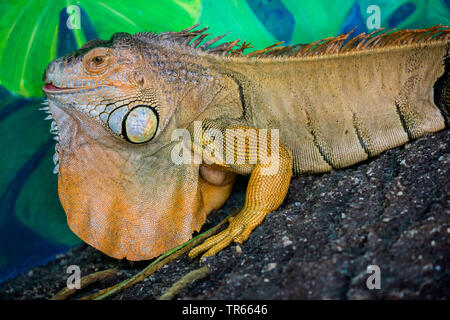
43;33;236;260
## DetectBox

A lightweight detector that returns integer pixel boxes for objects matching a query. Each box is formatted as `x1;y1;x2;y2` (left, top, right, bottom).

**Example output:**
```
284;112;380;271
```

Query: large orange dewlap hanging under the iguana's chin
58;121;233;260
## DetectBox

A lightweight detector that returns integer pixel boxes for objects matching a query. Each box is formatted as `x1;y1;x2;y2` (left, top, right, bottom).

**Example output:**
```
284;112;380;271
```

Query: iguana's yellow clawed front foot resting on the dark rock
189;208;268;258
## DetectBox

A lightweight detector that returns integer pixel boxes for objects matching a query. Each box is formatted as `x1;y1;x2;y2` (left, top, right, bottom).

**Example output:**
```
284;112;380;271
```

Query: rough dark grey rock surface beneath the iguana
0;130;450;299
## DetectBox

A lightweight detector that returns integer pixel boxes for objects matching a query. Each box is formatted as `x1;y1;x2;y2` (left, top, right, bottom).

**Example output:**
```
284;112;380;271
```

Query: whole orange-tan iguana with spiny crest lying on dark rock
43;25;450;260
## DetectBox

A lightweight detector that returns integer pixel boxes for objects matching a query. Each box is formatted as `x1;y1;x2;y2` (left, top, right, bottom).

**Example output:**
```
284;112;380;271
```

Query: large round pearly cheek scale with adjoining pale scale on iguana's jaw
108;105;158;143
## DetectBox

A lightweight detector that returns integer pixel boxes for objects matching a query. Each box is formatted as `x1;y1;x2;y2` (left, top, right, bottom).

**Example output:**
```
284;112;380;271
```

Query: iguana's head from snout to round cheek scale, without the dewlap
43;33;161;143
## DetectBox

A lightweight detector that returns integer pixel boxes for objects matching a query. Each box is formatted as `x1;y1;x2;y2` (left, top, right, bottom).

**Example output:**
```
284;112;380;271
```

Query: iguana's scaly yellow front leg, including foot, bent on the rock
189;122;293;258
